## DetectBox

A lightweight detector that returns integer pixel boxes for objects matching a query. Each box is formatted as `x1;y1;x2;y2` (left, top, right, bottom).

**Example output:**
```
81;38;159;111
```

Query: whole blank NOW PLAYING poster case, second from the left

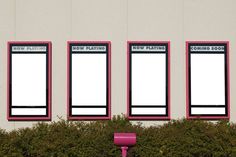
68;42;110;119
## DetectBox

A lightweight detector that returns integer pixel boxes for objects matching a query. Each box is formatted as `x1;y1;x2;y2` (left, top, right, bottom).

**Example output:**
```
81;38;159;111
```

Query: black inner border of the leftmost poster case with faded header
9;43;49;118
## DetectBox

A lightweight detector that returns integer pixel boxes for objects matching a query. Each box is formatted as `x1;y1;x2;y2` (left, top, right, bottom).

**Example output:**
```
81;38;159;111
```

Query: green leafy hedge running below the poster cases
0;116;236;157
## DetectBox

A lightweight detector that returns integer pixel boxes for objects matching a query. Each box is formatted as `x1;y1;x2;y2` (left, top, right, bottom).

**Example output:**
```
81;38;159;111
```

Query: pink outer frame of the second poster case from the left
67;41;111;120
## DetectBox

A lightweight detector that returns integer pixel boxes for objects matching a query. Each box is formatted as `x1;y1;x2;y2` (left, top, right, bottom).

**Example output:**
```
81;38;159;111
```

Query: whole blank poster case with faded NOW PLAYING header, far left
8;42;51;120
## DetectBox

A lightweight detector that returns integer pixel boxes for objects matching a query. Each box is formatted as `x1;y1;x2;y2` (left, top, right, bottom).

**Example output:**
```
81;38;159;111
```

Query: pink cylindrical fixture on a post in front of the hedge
114;133;136;157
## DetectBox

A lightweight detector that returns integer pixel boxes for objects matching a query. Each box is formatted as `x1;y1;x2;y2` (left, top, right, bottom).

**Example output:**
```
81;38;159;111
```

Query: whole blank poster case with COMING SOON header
187;42;229;118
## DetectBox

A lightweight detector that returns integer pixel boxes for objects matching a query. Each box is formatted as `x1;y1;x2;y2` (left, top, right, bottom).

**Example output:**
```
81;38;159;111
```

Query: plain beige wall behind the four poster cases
0;0;236;130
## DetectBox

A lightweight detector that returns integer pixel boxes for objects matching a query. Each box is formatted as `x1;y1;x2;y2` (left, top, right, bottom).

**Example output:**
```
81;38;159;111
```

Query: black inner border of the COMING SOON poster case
188;42;228;117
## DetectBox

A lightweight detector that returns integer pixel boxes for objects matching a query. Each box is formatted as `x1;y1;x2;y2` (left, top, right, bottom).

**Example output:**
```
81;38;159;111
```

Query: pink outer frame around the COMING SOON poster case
185;41;230;120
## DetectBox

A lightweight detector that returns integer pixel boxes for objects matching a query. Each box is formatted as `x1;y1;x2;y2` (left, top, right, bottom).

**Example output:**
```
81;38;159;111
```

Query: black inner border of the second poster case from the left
69;43;110;117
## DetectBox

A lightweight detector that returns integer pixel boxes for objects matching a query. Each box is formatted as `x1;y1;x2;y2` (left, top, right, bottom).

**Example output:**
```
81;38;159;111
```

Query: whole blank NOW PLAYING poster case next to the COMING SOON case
128;42;169;119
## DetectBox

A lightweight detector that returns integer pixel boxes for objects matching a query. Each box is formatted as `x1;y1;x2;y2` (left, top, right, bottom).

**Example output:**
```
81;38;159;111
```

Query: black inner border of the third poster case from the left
128;43;169;117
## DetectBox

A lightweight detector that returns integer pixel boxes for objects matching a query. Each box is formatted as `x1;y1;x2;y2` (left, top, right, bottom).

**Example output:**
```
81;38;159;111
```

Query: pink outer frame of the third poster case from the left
126;41;171;120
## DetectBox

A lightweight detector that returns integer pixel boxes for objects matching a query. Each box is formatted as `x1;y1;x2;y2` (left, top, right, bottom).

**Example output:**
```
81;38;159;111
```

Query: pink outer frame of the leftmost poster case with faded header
7;41;52;121
